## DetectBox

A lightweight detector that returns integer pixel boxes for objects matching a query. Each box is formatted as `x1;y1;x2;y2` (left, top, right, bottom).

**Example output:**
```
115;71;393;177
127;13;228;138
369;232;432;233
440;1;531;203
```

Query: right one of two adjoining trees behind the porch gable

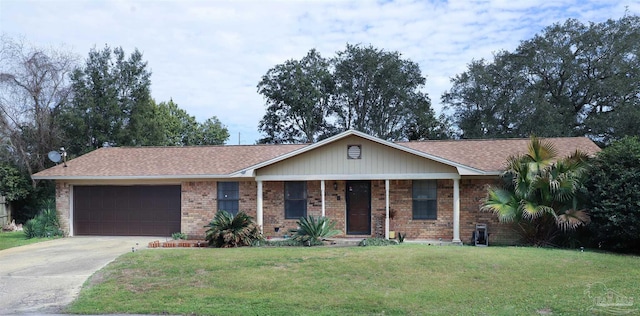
332;44;430;140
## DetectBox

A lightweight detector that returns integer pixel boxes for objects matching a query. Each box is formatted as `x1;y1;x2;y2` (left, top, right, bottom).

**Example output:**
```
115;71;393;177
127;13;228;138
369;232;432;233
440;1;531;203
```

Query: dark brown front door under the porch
347;181;371;235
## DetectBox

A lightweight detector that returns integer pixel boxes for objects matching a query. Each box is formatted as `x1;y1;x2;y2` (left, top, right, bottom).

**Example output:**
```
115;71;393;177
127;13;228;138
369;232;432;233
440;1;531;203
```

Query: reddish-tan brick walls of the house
56;179;518;244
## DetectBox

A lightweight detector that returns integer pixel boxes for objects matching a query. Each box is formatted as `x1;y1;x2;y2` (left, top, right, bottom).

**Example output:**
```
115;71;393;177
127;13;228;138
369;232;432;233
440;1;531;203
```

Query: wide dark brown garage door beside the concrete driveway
73;185;180;236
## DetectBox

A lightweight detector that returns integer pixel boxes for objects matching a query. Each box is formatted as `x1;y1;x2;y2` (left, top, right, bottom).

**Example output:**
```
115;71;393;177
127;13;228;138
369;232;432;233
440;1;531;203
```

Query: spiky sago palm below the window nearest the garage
205;210;262;248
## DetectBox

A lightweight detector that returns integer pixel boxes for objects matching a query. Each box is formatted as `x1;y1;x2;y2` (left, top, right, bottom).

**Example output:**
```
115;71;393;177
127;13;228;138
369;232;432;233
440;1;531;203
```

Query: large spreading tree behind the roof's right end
442;16;640;144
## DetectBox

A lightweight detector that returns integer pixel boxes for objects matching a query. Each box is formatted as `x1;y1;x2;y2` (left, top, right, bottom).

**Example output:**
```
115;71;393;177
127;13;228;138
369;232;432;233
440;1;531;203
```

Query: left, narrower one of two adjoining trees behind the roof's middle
258;49;333;143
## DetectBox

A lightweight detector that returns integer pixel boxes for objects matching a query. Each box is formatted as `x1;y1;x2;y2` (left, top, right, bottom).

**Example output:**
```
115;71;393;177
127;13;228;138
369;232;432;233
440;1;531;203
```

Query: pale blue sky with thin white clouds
0;0;640;144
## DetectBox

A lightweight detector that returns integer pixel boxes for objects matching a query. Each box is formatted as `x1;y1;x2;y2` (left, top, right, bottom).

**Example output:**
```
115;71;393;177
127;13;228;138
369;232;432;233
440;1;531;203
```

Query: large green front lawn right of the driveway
68;244;640;315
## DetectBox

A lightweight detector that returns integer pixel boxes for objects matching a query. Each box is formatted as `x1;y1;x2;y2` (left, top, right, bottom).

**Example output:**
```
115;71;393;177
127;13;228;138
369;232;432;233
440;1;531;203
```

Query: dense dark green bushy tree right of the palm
586;137;640;253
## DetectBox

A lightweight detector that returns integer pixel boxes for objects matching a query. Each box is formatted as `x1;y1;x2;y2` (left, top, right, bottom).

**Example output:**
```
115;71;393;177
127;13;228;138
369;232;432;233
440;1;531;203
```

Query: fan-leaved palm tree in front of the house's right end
482;137;589;245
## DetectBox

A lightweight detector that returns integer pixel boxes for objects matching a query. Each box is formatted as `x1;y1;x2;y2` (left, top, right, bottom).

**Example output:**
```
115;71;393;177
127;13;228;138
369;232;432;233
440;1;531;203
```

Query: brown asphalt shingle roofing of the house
34;137;600;179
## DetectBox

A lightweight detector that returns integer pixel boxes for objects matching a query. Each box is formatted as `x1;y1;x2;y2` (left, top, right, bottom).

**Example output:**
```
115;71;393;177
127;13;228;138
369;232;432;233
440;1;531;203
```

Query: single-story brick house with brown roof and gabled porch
33;130;600;243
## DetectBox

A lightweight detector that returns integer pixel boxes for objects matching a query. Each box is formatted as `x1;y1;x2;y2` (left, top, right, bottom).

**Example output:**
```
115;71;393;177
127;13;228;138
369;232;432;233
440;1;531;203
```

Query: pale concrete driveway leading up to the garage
0;237;159;315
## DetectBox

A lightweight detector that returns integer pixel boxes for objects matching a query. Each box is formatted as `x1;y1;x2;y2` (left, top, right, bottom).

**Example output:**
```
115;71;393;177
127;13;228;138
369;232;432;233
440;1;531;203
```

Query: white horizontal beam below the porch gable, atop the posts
256;173;460;181
